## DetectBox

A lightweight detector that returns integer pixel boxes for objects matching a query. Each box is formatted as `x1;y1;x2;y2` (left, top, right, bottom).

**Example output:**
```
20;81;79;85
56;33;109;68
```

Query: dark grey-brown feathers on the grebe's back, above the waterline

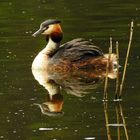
52;38;103;62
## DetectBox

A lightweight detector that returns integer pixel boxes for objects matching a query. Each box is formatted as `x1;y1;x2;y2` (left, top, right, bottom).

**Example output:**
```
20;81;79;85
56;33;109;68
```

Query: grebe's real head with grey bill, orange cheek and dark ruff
33;19;63;43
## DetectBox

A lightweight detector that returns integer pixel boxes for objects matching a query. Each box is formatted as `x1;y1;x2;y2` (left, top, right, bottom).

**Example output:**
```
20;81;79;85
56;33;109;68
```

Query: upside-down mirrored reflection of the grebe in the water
32;63;117;116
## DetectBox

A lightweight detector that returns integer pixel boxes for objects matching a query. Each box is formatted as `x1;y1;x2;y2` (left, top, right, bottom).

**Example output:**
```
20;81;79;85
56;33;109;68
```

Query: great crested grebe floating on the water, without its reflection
32;19;116;78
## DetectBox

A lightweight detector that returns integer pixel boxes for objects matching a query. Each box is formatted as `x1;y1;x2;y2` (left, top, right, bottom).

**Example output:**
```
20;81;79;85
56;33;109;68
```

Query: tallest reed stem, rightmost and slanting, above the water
119;21;134;99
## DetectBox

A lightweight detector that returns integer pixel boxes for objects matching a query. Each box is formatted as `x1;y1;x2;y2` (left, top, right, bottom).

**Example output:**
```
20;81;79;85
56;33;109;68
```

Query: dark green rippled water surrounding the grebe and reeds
0;0;140;140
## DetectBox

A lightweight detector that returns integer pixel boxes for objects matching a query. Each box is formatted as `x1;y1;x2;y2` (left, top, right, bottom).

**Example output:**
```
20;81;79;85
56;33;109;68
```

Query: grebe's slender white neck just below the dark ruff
41;38;60;55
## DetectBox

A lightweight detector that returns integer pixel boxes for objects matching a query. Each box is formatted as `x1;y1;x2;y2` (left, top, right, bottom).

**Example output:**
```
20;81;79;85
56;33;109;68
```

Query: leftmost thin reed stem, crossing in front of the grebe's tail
103;37;112;101
